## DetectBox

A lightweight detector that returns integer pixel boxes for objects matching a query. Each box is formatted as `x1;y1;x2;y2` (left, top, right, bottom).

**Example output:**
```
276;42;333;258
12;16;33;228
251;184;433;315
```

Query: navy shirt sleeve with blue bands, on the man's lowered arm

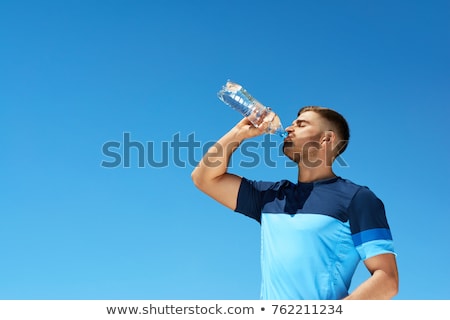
349;187;395;260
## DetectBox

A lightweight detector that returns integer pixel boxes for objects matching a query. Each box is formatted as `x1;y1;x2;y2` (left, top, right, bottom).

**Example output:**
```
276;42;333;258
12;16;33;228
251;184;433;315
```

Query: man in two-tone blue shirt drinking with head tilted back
192;107;398;300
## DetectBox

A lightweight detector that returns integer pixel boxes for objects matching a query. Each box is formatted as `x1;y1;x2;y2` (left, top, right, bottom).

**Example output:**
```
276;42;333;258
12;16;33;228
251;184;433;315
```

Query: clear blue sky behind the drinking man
0;0;450;299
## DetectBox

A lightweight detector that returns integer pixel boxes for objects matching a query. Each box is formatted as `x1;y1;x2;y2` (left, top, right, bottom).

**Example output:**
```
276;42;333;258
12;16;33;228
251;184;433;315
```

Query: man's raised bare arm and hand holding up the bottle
191;118;267;210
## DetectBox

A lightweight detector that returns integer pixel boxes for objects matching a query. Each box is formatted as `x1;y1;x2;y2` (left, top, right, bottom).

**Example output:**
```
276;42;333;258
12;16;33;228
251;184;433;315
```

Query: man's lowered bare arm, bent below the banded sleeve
344;253;399;300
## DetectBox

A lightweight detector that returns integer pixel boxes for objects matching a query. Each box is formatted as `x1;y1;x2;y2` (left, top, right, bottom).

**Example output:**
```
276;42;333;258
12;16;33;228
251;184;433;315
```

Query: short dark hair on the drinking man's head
297;106;350;156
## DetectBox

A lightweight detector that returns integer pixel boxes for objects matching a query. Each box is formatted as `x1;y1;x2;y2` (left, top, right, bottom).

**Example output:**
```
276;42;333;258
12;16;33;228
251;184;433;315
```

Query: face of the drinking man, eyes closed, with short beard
283;111;326;163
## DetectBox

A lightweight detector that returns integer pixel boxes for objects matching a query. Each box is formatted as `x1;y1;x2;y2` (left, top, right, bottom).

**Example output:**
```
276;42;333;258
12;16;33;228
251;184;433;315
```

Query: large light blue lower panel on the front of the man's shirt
261;213;360;299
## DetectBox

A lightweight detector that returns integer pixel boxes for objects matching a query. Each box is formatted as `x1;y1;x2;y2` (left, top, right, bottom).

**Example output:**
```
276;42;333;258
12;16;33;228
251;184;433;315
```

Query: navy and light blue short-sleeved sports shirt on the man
235;177;395;300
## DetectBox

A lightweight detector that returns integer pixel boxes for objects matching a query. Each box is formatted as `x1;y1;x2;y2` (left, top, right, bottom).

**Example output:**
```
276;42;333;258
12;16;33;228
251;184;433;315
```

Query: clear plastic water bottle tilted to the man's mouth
217;81;288;138
